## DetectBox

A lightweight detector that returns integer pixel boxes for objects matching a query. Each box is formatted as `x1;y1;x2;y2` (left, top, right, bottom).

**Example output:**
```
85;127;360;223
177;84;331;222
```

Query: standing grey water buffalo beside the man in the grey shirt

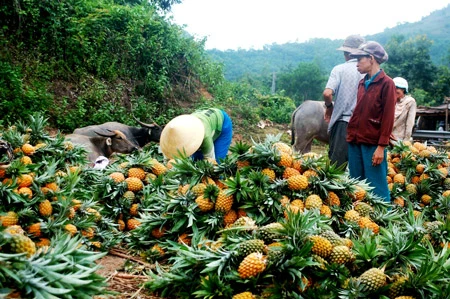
291;100;329;153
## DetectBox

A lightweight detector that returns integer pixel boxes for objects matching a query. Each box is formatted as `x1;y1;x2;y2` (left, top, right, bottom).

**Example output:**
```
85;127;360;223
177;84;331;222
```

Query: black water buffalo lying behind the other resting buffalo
73;120;163;147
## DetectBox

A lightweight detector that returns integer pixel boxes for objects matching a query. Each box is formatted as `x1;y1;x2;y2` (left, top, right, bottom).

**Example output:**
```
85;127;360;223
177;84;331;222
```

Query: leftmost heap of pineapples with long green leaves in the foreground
0;115;119;298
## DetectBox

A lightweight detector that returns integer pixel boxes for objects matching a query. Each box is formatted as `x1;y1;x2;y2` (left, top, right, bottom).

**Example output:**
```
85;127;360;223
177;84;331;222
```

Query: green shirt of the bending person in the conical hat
192;108;223;159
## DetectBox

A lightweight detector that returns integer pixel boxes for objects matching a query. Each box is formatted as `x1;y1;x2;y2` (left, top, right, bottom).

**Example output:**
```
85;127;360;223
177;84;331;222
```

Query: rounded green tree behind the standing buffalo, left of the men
277;62;326;106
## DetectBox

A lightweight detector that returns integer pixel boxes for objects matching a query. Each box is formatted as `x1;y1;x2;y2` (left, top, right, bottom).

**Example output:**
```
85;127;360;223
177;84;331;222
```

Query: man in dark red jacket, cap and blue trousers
346;41;396;202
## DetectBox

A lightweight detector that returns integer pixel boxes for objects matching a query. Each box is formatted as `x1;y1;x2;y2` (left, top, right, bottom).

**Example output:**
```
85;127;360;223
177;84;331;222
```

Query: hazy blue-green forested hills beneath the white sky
208;6;450;80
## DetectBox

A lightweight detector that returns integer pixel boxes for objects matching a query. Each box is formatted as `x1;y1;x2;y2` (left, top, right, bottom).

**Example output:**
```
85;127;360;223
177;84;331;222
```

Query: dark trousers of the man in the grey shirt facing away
328;121;348;166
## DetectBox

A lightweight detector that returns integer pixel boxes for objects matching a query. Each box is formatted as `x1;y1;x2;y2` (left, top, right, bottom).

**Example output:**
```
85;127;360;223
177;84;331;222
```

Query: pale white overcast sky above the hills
172;0;450;51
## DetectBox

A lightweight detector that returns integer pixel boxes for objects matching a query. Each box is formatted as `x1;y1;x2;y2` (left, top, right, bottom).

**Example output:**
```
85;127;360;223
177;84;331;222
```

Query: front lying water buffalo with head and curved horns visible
66;130;139;163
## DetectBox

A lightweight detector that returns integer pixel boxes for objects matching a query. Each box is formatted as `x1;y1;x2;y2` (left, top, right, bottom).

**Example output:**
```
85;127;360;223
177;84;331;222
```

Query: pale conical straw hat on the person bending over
159;114;205;159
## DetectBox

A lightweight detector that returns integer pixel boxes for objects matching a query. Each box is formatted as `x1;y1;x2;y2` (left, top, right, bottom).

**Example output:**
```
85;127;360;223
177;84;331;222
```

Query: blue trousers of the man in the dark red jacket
348;142;391;202
